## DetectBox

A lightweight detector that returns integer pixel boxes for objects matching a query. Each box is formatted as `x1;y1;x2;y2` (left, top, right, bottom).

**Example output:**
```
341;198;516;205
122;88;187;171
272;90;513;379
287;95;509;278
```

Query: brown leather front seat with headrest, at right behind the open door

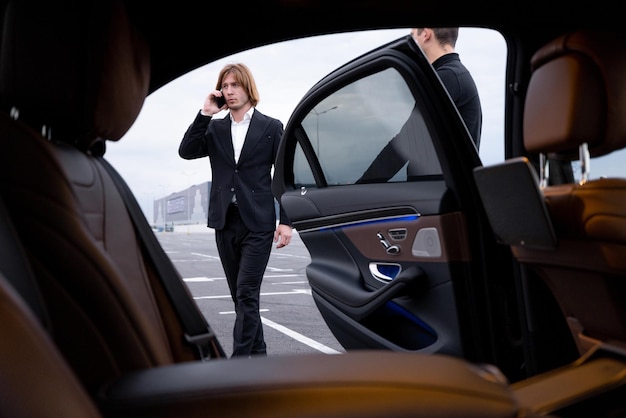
474;31;626;353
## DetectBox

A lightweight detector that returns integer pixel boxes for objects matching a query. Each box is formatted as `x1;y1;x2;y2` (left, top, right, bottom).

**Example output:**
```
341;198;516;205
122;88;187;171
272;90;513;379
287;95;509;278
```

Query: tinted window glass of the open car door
294;68;441;186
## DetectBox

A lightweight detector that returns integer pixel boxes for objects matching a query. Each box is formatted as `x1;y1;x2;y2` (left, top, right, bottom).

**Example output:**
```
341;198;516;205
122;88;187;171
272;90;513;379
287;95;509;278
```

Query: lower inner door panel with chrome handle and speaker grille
294;209;469;354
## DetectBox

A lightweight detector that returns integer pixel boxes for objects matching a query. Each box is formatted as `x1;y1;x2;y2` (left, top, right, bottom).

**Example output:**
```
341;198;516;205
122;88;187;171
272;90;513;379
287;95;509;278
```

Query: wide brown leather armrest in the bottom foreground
99;351;517;418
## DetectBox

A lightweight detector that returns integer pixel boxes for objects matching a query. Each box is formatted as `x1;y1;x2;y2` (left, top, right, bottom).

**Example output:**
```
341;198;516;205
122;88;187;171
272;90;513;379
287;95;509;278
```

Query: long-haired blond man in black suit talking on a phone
178;64;292;356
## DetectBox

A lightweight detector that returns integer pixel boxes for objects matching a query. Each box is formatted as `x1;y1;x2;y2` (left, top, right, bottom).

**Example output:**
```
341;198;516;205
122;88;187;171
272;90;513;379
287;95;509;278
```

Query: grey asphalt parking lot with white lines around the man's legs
156;226;344;356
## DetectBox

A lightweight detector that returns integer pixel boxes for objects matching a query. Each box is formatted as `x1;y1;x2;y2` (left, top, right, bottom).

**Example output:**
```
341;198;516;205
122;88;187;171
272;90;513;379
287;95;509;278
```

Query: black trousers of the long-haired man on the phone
215;205;274;357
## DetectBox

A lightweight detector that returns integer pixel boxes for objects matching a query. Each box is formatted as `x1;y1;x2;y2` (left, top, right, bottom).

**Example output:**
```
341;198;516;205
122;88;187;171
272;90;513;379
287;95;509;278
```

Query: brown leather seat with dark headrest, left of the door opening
0;0;204;391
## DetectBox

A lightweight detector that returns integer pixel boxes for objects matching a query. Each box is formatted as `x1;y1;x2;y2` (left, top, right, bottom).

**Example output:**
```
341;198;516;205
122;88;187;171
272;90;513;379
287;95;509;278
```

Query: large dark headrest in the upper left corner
0;0;150;150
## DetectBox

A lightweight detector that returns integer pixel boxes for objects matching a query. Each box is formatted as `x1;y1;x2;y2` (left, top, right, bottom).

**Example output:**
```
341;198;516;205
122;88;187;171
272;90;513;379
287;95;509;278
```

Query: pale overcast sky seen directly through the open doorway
106;28;506;221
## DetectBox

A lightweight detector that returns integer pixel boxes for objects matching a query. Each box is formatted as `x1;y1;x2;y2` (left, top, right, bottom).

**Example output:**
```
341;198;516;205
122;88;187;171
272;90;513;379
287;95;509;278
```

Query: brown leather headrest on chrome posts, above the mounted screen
524;31;626;160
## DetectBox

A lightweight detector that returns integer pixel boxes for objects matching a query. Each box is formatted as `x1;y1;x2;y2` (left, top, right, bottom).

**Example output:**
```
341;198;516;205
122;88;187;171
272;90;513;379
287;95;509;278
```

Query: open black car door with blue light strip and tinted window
273;36;521;374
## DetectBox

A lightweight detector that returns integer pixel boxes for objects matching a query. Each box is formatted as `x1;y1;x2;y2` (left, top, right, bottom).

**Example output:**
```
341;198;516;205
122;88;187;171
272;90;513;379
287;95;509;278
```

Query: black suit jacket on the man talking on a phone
178;109;290;232
